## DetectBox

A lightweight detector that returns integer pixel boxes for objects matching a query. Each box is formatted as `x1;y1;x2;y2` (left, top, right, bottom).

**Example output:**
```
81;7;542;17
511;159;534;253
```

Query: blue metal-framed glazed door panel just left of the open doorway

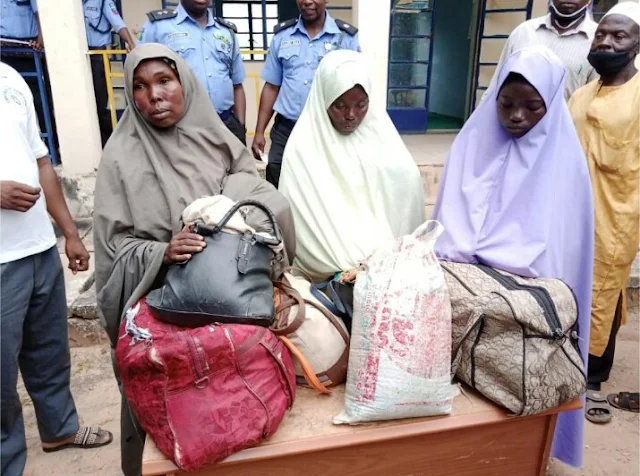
387;0;435;134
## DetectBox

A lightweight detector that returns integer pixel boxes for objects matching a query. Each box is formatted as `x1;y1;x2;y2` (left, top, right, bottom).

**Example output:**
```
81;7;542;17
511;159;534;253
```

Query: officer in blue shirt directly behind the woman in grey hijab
139;0;247;145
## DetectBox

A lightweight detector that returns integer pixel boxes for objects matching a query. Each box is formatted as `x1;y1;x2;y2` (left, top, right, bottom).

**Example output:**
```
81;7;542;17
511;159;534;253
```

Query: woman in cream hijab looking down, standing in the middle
279;50;425;280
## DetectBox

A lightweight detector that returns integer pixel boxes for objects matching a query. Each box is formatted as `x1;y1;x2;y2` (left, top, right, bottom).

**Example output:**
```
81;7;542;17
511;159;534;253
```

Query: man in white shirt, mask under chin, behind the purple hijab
483;0;598;100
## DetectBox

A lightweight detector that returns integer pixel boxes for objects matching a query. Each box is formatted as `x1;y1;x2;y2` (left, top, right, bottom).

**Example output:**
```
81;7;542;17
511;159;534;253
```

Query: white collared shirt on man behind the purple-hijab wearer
488;15;598;100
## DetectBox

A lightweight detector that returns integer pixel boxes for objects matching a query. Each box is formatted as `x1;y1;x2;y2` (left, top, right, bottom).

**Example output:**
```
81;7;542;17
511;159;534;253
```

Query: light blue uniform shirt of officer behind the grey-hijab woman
139;4;246;113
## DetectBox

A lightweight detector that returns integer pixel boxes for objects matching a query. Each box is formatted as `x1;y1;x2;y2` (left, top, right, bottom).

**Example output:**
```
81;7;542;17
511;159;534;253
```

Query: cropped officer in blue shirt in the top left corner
0;0;58;148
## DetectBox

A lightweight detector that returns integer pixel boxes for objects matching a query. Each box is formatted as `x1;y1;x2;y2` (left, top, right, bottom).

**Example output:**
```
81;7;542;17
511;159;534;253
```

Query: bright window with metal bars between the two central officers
222;0;278;61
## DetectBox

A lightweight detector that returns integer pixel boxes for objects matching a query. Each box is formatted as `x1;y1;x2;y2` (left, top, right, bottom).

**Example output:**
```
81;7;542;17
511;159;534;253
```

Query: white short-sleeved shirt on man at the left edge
0;62;56;263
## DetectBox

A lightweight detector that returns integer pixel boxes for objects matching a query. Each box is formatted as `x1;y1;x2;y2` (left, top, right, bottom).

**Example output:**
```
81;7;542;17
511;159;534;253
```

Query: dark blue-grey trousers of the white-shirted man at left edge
0;246;79;476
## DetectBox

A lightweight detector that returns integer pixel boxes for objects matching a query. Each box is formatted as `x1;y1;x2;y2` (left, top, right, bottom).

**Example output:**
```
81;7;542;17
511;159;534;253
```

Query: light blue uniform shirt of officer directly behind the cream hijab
262;13;360;121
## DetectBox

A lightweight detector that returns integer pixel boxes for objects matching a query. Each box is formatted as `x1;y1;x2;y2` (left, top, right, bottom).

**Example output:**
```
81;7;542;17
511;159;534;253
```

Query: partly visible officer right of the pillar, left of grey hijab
82;0;135;147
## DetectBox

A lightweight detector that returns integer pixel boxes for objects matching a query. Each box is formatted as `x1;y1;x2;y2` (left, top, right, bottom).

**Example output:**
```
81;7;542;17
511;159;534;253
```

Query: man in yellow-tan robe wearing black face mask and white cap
569;2;640;423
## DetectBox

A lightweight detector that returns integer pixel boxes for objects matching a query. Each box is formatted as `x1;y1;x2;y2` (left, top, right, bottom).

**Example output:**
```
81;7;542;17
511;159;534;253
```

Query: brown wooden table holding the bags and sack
142;387;582;476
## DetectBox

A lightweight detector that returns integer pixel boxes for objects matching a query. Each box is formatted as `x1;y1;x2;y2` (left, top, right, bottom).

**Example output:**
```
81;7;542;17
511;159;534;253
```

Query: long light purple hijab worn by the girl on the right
434;47;594;466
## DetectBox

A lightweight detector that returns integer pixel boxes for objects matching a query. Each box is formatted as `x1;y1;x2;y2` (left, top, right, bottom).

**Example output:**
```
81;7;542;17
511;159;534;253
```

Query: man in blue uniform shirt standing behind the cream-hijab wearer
252;0;360;187
